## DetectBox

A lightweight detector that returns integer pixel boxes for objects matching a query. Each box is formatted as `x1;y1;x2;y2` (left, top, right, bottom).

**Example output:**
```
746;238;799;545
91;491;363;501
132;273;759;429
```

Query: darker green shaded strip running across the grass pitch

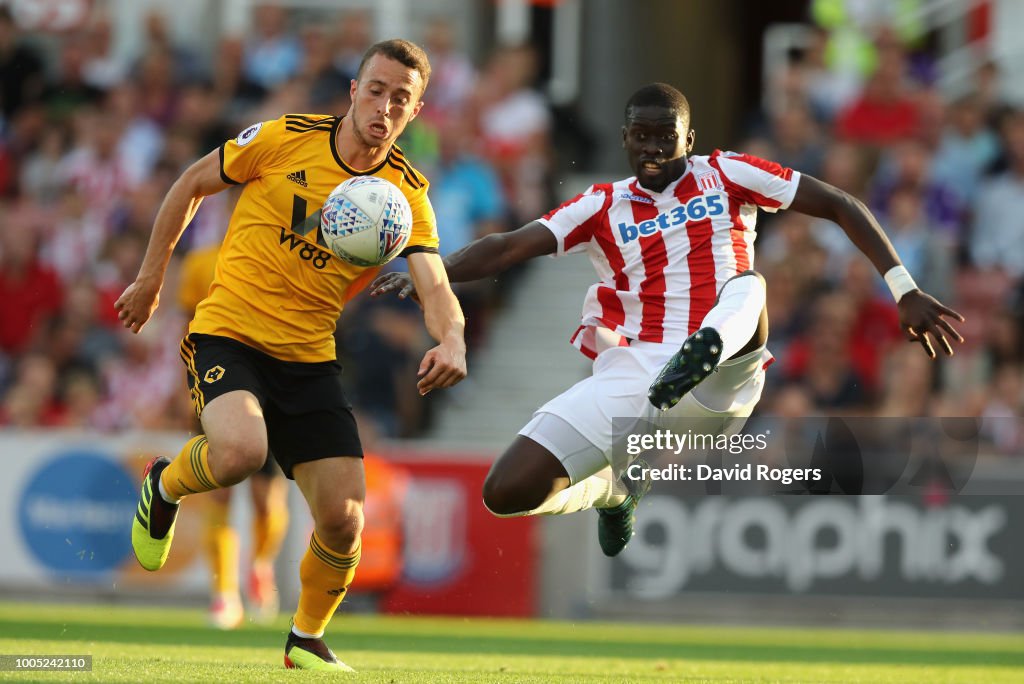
0;619;1024;667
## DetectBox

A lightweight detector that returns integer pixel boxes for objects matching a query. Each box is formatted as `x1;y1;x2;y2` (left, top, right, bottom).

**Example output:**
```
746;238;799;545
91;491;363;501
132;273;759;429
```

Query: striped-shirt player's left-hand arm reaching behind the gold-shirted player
370;221;558;299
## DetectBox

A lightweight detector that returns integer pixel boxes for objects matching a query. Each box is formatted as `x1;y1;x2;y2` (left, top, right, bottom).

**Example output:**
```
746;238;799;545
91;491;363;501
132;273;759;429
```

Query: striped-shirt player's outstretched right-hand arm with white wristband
790;174;964;358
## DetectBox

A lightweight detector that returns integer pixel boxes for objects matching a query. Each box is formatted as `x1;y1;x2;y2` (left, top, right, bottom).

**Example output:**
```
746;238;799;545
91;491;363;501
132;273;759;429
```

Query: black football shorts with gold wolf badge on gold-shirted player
181;333;362;479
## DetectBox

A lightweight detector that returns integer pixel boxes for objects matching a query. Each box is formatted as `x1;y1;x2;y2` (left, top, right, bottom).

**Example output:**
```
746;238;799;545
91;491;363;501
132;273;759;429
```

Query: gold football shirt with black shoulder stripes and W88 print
188;114;437;361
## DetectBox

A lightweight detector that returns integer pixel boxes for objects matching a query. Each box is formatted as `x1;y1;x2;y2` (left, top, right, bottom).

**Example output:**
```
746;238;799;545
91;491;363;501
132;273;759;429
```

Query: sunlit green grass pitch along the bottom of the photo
0;603;1024;684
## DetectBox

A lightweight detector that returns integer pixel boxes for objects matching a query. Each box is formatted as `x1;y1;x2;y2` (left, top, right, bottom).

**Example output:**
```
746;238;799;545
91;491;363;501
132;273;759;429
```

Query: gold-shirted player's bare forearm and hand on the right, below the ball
409;252;466;395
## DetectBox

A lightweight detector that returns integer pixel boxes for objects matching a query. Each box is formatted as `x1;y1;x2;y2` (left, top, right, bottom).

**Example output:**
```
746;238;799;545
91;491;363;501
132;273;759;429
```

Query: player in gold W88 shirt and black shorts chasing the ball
116;40;466;670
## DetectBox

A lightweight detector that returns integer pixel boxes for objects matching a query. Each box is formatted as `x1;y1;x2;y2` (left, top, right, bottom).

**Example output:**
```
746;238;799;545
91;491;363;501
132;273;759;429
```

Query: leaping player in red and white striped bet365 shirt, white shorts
371;83;963;556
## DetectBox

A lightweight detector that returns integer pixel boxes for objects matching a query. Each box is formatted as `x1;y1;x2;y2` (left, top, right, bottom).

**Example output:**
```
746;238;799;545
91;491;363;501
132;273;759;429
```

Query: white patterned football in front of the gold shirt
321;176;413;266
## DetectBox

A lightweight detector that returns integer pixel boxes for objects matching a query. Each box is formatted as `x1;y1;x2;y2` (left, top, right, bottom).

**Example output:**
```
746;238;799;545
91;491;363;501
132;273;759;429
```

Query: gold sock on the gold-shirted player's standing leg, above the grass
295;531;360;636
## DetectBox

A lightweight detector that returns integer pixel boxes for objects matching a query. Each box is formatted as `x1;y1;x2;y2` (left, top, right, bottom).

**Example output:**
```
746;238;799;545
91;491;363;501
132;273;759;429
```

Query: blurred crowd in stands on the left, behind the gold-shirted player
0;6;551;436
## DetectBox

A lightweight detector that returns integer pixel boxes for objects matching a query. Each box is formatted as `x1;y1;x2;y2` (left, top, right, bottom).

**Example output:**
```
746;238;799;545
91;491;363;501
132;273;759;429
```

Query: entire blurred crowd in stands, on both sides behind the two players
0;6;1024;453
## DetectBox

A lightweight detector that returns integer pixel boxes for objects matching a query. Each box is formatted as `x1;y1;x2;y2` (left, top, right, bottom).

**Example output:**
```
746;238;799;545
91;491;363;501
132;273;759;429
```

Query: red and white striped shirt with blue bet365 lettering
540;149;800;357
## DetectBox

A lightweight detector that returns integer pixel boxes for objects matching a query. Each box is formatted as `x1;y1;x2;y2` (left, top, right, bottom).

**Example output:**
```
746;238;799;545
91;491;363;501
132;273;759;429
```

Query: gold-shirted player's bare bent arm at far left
114;149;227;333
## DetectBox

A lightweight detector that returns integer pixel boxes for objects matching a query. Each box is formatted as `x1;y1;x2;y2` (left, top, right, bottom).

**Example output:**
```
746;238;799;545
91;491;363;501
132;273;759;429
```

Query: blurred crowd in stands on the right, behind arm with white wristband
739;17;1024;454
